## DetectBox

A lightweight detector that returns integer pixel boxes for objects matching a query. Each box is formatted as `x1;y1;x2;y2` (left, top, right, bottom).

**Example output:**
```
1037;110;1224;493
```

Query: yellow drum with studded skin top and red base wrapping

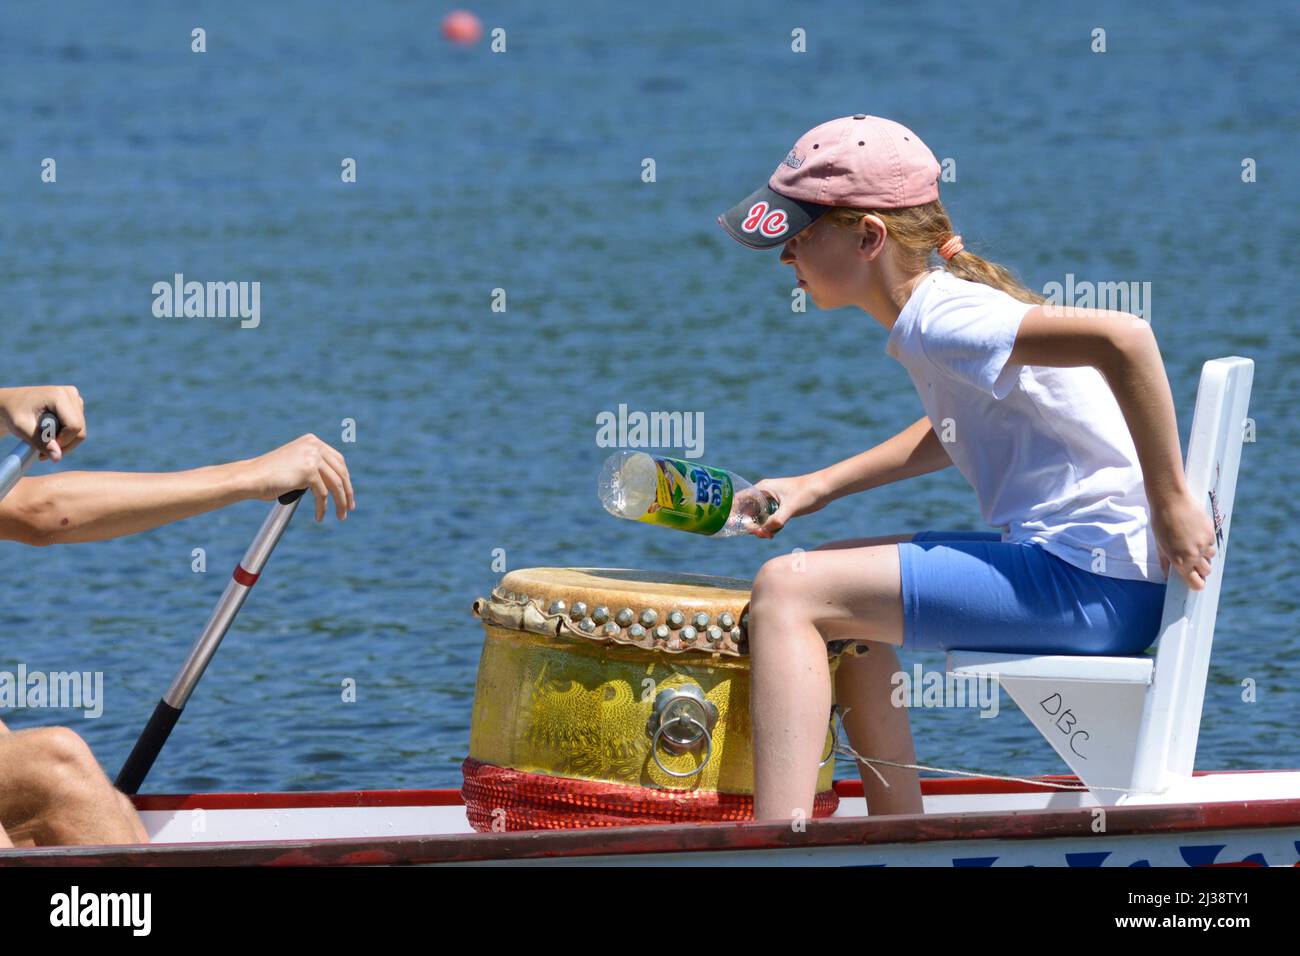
462;567;848;831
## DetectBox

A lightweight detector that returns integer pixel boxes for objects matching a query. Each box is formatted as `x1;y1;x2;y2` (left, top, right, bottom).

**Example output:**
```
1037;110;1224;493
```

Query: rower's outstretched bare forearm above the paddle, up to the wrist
0;462;257;545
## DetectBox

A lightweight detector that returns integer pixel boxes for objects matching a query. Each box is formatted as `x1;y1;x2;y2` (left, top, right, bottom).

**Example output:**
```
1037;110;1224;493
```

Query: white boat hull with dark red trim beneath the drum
0;771;1300;866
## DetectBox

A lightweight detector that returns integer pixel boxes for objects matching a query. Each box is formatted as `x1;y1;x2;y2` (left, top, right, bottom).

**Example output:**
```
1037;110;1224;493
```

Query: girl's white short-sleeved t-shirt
885;269;1166;583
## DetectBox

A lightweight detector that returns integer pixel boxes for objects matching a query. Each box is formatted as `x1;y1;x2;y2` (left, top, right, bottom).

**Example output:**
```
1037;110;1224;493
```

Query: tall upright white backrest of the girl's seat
1134;355;1255;792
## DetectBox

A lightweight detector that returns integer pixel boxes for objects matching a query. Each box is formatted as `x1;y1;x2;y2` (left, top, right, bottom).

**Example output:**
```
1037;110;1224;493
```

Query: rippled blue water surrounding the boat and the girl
0;0;1300;792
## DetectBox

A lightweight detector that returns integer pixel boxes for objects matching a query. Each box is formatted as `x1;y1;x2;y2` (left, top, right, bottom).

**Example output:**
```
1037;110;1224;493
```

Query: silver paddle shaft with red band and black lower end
114;488;307;795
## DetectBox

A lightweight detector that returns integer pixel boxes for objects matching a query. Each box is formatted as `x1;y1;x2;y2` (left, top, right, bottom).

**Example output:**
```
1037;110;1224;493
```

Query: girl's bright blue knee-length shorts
898;531;1167;657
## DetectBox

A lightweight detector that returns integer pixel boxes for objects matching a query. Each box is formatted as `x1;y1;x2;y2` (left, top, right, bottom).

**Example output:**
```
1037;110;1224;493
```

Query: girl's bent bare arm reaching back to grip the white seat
1008;306;1214;591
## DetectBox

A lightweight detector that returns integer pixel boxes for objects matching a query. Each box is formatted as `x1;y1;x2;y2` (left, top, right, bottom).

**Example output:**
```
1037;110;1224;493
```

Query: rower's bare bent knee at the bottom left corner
0;727;148;845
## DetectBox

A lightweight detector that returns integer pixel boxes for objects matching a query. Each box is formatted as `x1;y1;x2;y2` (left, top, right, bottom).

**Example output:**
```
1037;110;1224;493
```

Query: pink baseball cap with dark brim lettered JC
718;113;940;248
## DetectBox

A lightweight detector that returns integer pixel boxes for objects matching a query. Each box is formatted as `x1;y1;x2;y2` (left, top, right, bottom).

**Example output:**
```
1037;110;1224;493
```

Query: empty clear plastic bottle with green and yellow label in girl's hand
597;451;780;537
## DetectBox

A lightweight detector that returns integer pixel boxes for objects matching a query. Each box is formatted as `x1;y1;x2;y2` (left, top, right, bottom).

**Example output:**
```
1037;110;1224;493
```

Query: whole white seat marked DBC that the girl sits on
948;356;1255;804
